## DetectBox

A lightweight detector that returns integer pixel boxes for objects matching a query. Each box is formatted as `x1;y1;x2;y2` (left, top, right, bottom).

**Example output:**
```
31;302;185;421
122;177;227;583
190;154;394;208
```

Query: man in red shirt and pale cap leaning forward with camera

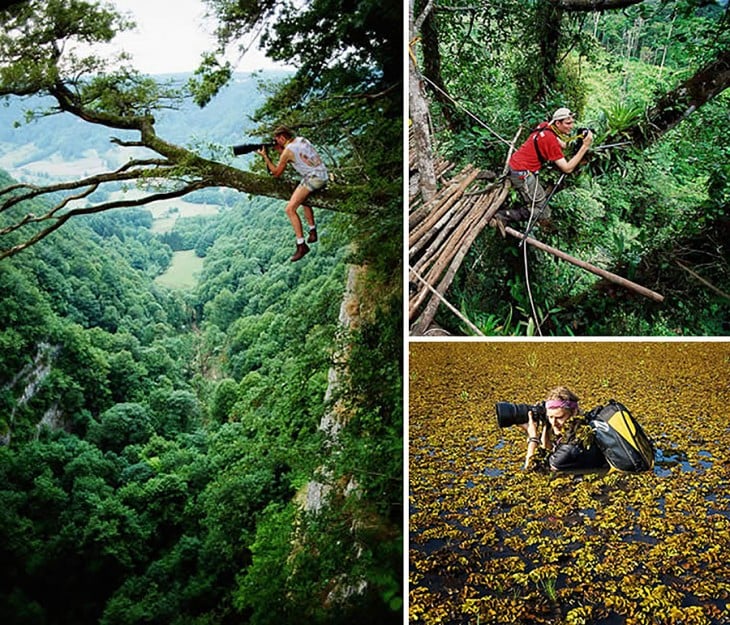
497;108;593;232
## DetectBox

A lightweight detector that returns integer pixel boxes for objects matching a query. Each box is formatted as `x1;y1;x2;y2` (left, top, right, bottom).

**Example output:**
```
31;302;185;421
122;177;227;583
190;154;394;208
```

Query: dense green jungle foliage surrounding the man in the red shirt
413;0;730;336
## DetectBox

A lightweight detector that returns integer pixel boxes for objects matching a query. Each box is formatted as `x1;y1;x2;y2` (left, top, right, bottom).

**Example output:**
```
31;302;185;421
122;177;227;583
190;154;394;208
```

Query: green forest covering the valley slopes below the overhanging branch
0;163;400;624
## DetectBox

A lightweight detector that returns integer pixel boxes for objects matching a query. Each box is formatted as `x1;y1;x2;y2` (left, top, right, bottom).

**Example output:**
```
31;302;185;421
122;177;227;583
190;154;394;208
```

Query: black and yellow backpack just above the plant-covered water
586;399;654;473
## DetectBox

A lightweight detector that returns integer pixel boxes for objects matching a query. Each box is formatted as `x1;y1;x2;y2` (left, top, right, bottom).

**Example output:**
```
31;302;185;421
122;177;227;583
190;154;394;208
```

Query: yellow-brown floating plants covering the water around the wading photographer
409;342;730;625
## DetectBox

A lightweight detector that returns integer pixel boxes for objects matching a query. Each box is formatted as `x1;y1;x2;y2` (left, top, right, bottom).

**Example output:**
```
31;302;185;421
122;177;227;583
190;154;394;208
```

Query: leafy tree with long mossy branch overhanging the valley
0;0;402;255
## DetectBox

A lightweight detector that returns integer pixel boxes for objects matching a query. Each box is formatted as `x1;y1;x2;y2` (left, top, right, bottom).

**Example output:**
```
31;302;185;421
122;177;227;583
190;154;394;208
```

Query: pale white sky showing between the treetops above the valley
111;0;288;74
